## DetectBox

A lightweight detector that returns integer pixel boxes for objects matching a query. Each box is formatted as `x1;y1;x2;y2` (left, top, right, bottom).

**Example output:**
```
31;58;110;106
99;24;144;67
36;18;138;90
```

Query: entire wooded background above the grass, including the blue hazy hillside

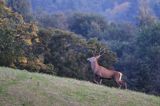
0;0;160;95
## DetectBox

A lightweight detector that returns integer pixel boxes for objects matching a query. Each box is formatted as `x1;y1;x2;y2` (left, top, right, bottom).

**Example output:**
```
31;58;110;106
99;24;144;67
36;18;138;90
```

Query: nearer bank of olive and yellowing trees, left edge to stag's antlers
0;2;115;81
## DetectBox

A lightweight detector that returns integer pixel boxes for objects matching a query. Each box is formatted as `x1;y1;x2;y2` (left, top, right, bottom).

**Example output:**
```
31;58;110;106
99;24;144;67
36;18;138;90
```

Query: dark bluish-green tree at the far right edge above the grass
136;23;160;93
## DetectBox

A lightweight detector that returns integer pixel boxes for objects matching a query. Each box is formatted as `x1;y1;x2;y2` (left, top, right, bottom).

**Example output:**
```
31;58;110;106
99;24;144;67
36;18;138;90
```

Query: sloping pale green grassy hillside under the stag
0;67;160;106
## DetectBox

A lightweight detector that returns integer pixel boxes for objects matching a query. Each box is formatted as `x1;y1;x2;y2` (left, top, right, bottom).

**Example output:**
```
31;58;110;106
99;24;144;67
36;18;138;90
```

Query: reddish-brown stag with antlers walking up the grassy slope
87;49;127;89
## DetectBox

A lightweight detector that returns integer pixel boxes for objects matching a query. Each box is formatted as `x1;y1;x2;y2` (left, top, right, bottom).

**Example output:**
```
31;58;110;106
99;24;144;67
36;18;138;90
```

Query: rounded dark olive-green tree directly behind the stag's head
39;29;115;80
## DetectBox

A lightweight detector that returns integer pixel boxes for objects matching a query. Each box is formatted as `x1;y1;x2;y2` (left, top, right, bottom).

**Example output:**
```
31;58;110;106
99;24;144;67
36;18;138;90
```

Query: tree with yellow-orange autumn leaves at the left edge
0;4;54;74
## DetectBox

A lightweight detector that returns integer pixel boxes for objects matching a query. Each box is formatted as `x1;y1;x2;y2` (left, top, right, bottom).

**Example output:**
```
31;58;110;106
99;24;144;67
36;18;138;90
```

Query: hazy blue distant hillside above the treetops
30;0;160;23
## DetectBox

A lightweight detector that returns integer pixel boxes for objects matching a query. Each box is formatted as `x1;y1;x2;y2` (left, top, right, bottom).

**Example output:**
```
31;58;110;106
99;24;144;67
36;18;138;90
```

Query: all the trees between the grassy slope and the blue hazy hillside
0;0;160;95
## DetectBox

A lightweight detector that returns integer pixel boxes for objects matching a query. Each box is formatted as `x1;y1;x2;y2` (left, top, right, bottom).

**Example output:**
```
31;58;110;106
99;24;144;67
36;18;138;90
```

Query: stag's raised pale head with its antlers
87;48;105;62
